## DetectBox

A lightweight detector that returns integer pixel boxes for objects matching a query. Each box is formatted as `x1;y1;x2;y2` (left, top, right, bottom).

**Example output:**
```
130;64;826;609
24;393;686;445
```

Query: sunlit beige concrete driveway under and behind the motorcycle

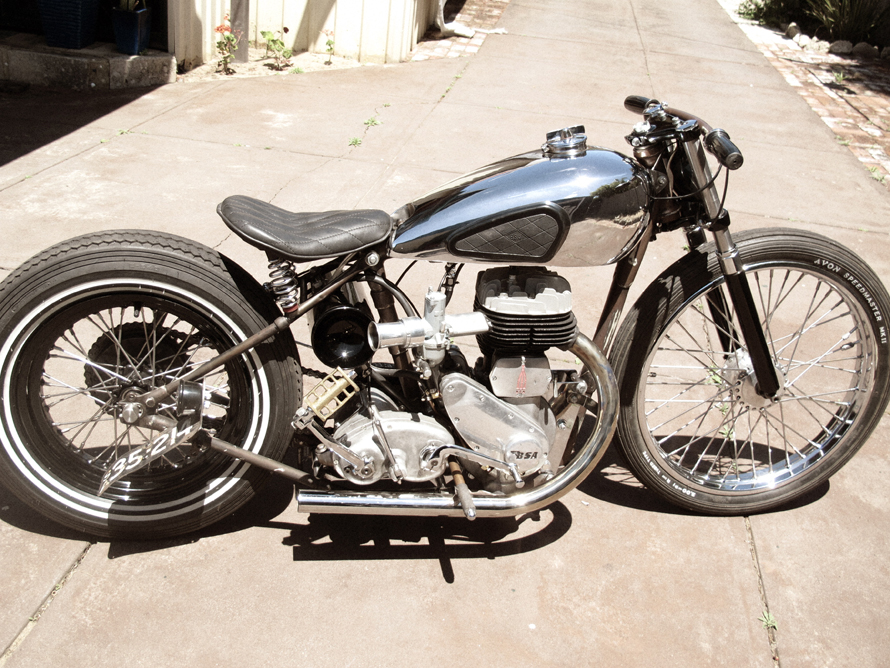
0;0;890;668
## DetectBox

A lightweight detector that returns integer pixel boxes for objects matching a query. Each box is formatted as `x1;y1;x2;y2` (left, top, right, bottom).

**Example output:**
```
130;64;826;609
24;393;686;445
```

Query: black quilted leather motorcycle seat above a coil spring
216;195;393;262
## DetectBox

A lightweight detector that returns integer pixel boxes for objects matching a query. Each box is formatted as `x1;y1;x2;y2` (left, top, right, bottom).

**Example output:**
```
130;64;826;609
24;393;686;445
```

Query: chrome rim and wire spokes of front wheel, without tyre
637;264;876;494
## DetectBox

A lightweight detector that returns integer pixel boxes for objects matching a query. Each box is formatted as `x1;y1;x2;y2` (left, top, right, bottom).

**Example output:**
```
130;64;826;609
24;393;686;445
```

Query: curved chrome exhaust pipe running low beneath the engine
297;333;618;517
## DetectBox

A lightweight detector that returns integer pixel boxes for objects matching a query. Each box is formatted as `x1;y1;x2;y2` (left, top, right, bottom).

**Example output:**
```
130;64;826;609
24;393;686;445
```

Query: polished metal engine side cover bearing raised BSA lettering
440;373;555;476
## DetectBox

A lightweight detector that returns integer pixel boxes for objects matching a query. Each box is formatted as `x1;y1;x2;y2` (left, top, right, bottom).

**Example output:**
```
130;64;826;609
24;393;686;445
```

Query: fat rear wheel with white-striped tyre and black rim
0;232;301;538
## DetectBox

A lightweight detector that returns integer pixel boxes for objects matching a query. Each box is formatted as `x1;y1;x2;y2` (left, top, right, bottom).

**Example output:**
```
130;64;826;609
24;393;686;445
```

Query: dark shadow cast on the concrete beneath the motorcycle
0;448;830;564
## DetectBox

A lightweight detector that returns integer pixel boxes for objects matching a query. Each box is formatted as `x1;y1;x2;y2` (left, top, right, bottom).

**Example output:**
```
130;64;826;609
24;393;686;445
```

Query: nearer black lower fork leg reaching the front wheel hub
711;219;779;397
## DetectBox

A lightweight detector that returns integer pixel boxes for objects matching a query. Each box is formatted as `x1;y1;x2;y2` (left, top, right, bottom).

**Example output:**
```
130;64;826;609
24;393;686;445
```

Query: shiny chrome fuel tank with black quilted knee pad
392;127;650;267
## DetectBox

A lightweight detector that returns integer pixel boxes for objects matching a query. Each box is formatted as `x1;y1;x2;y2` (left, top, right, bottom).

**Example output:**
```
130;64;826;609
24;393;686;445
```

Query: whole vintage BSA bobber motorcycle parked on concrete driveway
0;96;890;538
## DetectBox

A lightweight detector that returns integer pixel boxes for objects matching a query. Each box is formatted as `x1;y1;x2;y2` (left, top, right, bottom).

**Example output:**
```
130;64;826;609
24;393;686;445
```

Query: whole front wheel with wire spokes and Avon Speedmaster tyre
612;230;890;515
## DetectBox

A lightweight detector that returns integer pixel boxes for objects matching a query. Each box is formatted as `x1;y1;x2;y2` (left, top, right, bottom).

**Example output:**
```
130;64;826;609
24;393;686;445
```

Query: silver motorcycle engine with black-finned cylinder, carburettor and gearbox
298;267;577;491
